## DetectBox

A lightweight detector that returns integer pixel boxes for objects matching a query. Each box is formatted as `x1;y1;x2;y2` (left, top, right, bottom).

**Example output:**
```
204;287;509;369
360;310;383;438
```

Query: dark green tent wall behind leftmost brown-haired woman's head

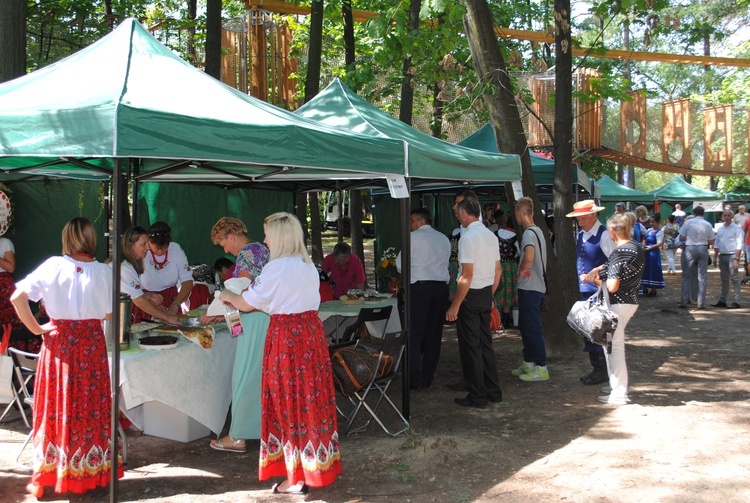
4;179;108;280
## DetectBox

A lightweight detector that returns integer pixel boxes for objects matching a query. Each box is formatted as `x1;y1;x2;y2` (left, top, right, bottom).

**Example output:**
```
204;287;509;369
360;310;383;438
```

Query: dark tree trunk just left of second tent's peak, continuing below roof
305;0;323;264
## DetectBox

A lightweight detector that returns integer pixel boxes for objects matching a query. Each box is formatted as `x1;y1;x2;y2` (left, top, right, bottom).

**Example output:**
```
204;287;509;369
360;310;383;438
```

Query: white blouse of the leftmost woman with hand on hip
16;255;112;320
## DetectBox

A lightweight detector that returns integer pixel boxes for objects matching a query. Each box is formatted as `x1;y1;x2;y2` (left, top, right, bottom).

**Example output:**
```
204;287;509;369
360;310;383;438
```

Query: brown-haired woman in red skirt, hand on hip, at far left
11;218;123;498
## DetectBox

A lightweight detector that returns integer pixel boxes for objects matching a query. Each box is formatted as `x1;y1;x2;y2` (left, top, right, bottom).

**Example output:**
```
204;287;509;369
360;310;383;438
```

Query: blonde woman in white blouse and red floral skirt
221;213;341;494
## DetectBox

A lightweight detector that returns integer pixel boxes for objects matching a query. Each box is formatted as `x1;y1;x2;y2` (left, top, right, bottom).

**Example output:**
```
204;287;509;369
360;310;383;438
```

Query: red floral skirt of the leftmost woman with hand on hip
31;320;123;494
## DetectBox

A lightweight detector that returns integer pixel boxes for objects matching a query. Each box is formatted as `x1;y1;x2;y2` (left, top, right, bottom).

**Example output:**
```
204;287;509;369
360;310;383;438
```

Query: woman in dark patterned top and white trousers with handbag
587;213;644;405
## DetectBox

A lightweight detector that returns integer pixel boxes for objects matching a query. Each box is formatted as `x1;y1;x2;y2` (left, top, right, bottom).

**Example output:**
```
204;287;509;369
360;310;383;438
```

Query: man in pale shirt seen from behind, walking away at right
680;206;716;310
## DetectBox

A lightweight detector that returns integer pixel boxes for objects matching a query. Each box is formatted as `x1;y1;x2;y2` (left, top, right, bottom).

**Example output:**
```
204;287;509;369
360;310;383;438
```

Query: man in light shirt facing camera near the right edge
711;210;745;309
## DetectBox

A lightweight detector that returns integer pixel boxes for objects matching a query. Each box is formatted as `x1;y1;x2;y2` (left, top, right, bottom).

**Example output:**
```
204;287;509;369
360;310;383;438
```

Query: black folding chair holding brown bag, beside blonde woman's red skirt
336;330;409;437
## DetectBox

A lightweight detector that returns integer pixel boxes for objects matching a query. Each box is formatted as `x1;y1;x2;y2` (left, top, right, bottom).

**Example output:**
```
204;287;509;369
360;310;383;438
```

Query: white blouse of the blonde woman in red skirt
242;256;320;315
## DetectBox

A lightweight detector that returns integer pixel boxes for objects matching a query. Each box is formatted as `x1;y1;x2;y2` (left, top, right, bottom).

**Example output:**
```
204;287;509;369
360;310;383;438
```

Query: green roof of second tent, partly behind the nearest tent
295;79;521;182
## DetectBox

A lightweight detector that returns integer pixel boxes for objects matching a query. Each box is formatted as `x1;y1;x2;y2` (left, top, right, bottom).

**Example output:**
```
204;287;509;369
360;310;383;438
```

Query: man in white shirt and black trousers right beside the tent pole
396;208;451;389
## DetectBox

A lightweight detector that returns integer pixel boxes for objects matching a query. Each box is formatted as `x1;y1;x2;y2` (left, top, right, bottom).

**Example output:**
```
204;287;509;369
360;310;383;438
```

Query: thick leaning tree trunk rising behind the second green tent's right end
463;0;580;352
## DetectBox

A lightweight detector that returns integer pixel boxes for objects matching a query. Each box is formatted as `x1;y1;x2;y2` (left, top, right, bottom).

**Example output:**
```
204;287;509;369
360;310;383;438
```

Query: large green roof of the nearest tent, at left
0;19;418;187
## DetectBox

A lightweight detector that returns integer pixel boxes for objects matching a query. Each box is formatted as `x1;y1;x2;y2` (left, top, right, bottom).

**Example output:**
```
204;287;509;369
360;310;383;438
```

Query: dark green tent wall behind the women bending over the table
137;182;294;266
